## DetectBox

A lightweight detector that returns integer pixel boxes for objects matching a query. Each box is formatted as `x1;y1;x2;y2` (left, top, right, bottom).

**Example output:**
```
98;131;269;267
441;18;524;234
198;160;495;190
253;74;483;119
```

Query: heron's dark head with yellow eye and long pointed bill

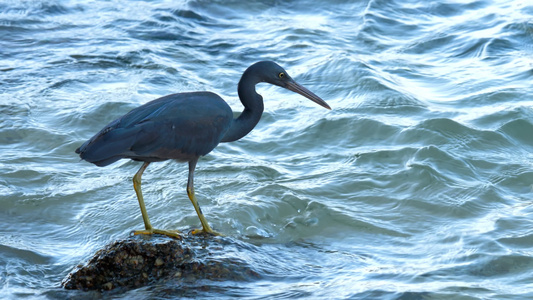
246;61;331;109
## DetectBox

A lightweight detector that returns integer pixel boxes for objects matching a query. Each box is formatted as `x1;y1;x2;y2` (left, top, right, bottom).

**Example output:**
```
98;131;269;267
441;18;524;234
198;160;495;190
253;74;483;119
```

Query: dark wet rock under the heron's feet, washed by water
62;235;259;290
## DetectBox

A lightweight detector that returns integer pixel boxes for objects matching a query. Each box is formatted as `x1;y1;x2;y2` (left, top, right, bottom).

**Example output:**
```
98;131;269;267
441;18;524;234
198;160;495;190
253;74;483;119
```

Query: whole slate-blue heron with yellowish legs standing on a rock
75;61;331;238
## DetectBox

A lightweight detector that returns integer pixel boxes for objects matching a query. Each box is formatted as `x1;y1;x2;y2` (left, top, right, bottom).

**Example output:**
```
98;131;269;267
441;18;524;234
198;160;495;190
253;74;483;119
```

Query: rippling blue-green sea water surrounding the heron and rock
0;0;533;299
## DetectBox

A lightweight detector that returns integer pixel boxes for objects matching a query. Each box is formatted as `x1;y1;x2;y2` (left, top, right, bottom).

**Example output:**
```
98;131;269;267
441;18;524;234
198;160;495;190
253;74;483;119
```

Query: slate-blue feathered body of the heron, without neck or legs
77;92;233;167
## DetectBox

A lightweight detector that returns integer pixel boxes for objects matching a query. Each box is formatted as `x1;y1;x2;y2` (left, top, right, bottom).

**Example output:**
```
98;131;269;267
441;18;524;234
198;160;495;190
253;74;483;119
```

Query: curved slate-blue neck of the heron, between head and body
221;72;264;142
